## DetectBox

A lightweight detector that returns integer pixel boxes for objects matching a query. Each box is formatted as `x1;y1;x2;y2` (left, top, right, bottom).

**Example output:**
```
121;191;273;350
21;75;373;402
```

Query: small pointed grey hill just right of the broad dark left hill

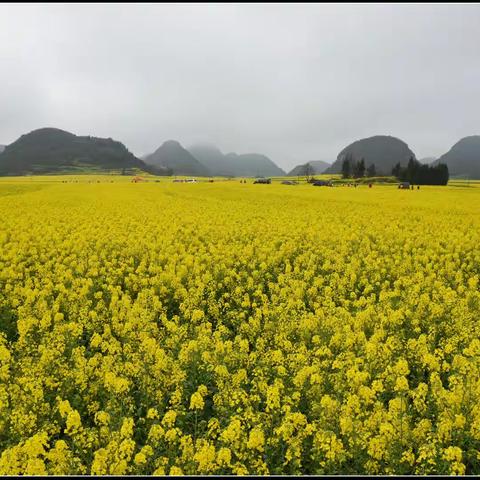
144;140;210;177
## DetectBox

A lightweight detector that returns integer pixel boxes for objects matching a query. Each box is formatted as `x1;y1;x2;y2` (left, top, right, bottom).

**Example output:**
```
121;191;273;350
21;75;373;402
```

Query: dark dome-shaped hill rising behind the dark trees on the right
324;135;416;175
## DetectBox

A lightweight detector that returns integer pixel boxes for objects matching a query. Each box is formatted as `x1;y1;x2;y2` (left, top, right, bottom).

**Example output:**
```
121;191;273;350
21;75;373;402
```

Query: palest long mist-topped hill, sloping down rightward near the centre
189;144;285;177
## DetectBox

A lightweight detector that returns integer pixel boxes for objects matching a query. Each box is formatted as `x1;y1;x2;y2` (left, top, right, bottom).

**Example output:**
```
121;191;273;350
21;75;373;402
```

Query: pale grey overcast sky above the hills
0;4;480;168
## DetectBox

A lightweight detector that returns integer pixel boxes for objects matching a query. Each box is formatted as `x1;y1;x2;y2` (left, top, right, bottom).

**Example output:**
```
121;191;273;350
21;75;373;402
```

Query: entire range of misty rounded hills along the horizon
0;128;480;178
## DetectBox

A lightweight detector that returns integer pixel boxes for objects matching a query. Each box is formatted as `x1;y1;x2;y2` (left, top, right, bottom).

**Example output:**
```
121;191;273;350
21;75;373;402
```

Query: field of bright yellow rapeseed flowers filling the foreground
0;177;480;475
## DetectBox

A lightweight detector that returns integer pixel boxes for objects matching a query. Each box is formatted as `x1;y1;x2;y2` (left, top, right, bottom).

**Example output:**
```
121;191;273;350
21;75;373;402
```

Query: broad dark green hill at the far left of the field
0;128;151;175
